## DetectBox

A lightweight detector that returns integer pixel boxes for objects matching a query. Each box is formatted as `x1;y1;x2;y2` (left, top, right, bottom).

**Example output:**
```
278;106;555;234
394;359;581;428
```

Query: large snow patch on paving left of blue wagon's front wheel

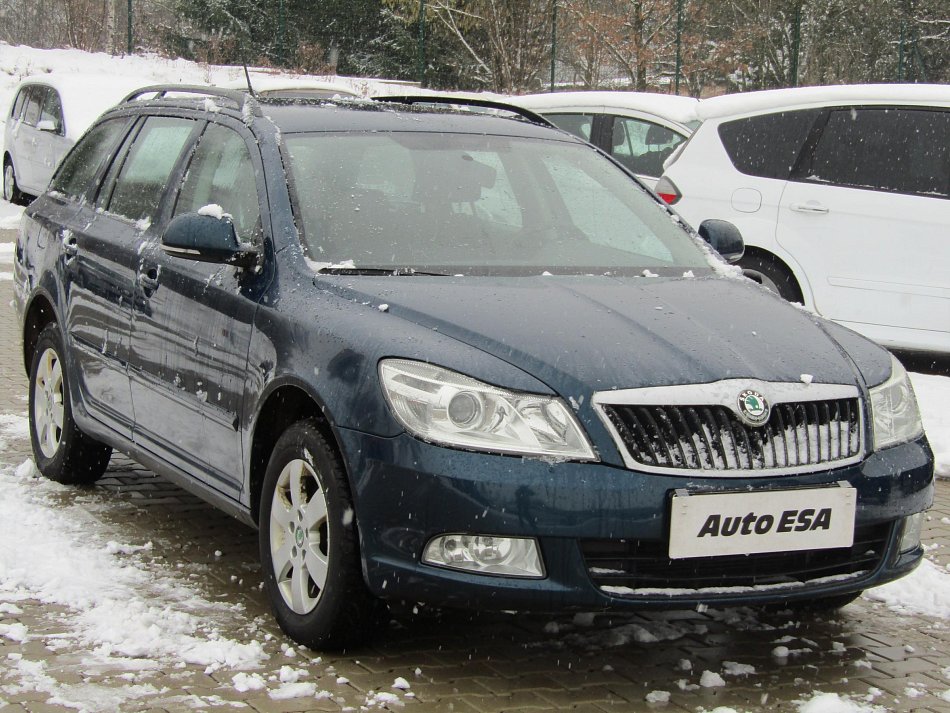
0;444;268;670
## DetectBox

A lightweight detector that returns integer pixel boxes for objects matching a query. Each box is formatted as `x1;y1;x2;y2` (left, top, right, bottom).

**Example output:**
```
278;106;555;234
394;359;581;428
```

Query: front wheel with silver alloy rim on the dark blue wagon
258;419;385;650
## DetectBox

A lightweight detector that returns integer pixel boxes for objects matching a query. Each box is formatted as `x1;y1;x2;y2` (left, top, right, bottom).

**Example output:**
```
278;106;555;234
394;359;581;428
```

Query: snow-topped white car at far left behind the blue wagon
3;74;148;203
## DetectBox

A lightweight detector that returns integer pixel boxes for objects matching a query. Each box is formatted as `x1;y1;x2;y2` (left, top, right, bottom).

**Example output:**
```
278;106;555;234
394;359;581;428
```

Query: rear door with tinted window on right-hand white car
777;107;950;350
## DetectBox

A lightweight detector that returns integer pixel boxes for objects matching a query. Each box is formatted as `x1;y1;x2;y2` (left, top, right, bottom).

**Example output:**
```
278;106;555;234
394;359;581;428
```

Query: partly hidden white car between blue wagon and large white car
511;92;699;187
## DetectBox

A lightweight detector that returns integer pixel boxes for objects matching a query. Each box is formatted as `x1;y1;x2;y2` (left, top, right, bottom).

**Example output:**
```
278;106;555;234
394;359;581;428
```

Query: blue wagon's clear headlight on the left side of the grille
379;359;596;460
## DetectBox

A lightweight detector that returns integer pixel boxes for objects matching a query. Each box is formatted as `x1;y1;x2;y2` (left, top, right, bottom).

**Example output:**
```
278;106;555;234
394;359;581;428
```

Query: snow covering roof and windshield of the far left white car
14;72;154;141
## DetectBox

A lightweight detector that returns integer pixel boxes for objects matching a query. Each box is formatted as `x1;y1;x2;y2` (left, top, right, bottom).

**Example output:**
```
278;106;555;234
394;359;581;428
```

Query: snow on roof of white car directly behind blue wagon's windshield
508;91;700;124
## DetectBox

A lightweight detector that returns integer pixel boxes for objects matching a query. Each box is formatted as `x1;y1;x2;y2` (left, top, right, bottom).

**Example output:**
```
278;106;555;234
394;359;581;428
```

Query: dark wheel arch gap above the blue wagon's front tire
248;381;346;524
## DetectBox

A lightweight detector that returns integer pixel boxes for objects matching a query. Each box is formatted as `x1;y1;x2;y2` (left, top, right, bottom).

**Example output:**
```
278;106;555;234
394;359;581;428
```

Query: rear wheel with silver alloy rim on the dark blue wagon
30;323;112;485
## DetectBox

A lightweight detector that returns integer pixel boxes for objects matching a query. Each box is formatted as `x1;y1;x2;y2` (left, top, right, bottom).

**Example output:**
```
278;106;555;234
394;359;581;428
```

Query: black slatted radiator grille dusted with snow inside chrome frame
599;387;863;475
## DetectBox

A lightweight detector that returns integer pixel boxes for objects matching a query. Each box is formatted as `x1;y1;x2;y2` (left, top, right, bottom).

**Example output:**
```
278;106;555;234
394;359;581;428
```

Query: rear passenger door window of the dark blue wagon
108;116;195;221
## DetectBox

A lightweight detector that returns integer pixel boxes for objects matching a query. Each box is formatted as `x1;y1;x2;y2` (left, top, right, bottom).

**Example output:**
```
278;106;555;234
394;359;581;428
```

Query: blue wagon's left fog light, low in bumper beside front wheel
422;534;544;578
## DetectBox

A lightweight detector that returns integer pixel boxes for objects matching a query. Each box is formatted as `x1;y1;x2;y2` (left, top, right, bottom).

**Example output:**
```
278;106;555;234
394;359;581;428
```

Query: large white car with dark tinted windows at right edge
657;84;950;353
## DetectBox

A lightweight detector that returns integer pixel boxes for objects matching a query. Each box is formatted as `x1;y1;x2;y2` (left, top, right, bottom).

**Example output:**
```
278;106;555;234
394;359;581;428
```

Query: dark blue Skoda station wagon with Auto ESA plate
14;87;933;647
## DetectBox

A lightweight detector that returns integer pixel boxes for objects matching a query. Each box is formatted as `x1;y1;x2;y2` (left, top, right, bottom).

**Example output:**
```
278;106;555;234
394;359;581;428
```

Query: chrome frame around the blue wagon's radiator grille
591;379;867;478
